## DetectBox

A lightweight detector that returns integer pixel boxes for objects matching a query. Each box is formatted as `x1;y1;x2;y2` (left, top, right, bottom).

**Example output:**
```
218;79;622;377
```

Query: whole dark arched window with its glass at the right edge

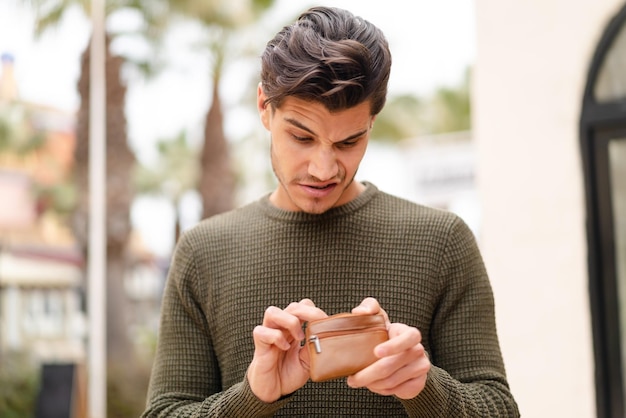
580;6;626;418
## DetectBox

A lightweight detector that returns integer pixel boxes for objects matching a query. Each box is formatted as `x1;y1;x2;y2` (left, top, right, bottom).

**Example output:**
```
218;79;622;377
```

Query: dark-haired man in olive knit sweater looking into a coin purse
144;7;519;418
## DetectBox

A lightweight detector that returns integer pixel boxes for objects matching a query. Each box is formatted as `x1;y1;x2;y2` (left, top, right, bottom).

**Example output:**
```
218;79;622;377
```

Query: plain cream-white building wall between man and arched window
472;0;623;418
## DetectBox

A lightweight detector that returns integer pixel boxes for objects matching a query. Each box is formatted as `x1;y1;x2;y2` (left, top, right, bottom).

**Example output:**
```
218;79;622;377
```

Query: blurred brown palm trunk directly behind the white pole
73;37;135;362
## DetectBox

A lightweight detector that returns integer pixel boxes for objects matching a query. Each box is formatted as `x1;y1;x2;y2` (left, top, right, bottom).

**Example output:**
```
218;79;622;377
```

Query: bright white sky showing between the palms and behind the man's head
0;0;476;253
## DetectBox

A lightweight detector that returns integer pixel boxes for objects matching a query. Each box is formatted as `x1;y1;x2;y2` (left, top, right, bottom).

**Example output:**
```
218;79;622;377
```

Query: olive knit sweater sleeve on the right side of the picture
401;218;519;418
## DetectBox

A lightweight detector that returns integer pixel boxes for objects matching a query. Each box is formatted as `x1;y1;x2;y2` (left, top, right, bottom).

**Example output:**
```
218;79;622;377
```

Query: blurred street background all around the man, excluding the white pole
0;0;626;418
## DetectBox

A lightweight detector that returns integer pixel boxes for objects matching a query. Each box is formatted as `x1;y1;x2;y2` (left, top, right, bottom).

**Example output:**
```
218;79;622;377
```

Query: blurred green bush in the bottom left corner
0;352;39;418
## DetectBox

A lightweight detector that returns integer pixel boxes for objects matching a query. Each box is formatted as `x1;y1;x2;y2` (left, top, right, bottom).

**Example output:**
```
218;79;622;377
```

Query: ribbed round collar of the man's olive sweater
259;181;378;222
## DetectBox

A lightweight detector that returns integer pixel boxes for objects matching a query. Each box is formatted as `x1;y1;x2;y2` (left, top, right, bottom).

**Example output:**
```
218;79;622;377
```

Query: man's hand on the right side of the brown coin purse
347;298;431;399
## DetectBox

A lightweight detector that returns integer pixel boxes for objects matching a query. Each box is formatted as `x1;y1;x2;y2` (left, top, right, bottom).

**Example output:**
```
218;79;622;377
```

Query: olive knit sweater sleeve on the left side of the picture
142;236;288;418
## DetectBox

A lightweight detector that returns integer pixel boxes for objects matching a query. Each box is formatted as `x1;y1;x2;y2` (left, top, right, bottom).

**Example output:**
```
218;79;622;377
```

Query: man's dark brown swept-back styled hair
261;7;391;115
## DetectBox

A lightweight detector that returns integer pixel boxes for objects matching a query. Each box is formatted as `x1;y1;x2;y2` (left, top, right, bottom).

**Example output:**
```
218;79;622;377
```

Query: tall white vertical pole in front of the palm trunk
87;0;106;418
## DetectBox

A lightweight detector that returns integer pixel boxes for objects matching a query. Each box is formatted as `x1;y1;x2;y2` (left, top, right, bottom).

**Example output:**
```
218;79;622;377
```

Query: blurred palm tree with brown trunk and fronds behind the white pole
24;0;167;362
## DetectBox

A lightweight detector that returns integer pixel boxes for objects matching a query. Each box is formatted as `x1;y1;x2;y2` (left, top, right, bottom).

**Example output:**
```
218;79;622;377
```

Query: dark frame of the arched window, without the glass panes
580;5;626;418
